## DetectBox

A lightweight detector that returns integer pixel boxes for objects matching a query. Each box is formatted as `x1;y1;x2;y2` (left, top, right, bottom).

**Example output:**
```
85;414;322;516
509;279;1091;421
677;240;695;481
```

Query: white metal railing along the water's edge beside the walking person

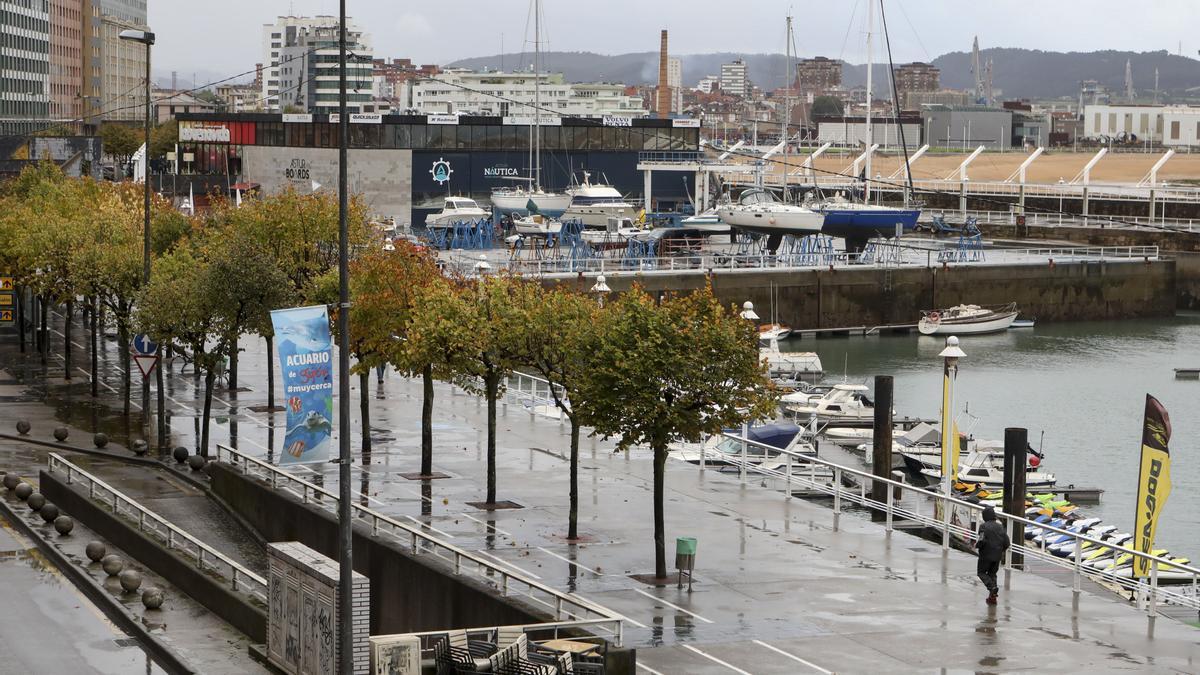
700;434;1200;617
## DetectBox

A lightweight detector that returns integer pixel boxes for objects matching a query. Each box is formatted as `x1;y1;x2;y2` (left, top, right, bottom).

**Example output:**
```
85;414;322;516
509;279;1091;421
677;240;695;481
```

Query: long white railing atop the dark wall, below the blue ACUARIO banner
216;443;625;645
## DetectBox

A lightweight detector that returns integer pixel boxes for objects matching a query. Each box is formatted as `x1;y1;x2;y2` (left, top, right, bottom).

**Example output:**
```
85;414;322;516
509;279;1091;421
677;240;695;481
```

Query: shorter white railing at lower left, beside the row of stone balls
48;453;266;603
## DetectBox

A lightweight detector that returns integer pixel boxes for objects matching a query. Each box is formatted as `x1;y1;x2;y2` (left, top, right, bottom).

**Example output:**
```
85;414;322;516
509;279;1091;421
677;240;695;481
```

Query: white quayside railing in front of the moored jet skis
701;432;1200;614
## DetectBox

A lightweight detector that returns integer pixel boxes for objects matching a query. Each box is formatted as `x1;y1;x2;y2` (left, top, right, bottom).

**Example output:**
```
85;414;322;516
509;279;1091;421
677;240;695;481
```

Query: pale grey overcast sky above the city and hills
149;0;1200;83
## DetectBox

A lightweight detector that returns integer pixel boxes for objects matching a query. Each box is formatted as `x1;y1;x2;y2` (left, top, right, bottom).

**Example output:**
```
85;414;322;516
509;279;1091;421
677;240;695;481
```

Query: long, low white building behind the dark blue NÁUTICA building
397;70;649;118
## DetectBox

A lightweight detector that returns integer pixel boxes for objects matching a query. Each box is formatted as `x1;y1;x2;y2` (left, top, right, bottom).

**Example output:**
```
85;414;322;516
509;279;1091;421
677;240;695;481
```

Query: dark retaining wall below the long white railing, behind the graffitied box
208;462;551;635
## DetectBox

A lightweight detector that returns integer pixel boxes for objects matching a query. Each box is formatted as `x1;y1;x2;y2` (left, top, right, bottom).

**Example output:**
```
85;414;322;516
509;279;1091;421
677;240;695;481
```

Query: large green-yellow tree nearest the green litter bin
580;281;775;578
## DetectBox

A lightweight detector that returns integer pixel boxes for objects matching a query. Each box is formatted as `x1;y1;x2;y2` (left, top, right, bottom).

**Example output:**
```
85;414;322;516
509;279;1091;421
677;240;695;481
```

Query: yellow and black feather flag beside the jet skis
1133;394;1171;578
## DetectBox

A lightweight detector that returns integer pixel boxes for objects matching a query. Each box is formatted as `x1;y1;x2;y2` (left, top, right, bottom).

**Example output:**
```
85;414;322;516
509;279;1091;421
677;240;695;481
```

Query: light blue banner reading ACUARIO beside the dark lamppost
271;306;334;464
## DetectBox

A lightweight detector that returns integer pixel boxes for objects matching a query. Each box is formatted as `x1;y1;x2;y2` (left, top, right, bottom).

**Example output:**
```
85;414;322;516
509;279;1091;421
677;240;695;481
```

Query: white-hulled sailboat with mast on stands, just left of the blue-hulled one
716;17;826;241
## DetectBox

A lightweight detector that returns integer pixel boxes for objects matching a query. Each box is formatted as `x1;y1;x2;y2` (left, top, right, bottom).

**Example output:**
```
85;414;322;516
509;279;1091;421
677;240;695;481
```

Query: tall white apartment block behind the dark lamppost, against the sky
260;16;373;113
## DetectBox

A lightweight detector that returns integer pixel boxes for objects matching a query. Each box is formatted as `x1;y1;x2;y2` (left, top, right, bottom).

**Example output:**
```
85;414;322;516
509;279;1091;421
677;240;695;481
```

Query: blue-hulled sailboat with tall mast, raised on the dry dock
814;0;920;251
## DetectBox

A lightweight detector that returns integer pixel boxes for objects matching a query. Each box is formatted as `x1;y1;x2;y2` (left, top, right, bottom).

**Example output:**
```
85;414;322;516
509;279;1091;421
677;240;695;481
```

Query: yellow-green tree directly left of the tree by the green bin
502;282;599;540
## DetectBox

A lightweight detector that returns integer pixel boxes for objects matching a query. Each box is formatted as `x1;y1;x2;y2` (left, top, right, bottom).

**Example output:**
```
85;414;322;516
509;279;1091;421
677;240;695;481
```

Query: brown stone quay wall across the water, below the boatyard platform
547;261;1171;329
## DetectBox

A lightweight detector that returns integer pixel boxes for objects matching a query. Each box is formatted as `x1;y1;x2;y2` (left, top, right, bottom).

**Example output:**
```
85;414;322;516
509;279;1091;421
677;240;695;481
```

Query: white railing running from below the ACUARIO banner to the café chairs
216;443;625;646
